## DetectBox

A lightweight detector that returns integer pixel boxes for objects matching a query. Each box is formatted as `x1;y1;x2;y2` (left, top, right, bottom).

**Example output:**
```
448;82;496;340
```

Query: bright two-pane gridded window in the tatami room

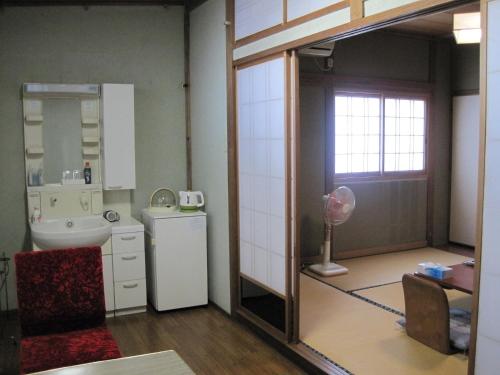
334;92;426;178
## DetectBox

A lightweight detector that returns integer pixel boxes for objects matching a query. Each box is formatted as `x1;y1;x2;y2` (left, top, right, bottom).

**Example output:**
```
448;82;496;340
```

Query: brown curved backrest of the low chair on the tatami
403;274;452;354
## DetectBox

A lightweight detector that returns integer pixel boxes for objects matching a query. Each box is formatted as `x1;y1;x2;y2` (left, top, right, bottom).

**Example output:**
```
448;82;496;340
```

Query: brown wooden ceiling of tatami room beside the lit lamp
387;3;479;38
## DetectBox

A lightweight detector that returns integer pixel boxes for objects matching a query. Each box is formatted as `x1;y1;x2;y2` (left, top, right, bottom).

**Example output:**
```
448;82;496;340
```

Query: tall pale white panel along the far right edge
475;0;500;375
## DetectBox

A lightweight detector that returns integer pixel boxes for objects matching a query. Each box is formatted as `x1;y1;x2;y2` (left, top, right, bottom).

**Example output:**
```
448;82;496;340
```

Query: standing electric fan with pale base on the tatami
309;186;356;276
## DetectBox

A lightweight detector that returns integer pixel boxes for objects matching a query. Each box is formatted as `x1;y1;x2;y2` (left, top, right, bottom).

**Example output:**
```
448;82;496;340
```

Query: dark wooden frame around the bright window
325;85;432;185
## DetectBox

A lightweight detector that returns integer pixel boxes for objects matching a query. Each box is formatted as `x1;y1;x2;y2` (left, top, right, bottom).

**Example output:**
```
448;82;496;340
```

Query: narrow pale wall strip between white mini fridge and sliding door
190;0;231;312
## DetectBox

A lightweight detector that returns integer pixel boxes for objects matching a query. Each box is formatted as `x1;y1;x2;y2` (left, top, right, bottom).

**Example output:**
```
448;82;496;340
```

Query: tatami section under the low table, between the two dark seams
353;282;472;314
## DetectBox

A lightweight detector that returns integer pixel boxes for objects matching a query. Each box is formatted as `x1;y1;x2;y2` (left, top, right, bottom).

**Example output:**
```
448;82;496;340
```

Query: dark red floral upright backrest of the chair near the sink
15;247;106;336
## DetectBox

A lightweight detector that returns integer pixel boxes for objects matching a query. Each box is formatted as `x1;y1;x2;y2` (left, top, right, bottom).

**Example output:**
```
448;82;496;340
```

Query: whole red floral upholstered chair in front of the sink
15;247;121;373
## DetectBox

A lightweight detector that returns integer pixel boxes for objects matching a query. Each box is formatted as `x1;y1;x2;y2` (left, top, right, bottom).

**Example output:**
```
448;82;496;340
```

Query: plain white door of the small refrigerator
155;216;208;311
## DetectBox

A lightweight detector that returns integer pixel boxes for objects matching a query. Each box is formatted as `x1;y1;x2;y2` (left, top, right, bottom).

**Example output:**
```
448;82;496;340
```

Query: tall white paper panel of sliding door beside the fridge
237;58;286;295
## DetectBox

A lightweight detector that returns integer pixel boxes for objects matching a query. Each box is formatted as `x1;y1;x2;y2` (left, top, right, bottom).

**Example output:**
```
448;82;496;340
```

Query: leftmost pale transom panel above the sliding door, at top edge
234;0;283;40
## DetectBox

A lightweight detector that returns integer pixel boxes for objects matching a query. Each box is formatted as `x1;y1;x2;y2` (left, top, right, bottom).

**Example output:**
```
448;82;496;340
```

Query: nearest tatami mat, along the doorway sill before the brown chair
300;275;467;375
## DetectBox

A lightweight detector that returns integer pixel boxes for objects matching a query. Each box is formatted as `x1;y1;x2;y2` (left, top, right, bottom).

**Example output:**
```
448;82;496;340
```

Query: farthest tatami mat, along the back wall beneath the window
304;247;468;291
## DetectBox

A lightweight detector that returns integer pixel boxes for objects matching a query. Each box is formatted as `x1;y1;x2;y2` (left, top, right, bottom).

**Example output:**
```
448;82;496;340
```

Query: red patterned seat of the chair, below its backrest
20;326;121;374
